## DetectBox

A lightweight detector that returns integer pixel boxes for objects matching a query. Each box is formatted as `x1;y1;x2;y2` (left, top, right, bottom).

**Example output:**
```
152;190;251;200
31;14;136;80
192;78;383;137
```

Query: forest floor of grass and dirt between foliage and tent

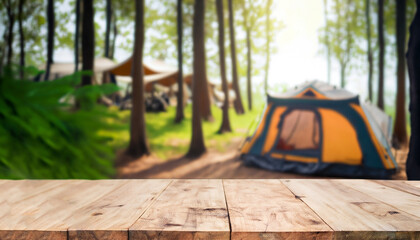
111;106;407;179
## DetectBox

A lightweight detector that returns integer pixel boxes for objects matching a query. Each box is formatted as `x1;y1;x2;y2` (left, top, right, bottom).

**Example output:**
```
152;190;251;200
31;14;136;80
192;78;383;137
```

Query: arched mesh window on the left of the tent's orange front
276;109;319;150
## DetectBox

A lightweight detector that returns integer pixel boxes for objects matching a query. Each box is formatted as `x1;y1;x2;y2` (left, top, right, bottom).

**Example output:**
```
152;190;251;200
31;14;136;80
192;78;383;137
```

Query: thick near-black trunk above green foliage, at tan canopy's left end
82;0;95;86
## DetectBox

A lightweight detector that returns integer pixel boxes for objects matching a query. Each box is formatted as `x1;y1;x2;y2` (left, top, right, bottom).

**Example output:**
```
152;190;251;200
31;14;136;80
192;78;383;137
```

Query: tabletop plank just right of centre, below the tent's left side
223;179;333;239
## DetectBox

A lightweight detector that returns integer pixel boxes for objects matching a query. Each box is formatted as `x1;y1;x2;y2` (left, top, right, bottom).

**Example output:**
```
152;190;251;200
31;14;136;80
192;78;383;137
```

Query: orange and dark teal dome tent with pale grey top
241;81;397;178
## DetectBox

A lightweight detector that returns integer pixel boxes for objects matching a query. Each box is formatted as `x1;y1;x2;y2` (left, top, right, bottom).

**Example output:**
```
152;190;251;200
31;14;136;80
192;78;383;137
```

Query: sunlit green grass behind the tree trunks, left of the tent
102;105;263;159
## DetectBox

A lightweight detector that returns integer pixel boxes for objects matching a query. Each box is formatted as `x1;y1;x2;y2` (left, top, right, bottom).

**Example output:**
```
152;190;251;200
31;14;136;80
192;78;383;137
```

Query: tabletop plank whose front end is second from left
69;179;171;240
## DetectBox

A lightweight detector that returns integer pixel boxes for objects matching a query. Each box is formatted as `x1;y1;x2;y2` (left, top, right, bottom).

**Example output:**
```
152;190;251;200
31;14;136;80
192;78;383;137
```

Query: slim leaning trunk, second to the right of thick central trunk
228;0;245;114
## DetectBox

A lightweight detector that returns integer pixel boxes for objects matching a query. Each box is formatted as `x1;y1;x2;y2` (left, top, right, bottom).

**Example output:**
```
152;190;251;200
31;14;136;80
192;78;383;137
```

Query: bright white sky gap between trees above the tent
269;0;327;86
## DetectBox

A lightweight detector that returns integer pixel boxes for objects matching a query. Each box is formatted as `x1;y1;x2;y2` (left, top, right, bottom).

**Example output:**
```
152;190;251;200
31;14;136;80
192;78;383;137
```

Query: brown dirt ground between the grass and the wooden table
117;139;406;179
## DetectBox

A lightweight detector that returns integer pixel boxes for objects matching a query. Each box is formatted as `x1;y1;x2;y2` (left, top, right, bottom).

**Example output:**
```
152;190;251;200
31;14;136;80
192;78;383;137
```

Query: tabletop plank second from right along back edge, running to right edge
337;180;420;219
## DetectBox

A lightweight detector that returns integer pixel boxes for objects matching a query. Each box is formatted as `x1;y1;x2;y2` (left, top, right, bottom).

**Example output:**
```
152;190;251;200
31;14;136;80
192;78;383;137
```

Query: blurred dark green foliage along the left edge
0;67;120;179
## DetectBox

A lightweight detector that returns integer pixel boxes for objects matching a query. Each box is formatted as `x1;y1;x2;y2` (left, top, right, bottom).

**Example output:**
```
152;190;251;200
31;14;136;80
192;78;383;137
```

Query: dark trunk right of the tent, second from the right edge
393;0;407;147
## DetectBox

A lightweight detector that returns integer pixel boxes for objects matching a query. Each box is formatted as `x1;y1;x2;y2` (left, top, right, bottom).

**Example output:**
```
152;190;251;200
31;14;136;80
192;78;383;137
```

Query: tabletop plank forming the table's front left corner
0;180;121;239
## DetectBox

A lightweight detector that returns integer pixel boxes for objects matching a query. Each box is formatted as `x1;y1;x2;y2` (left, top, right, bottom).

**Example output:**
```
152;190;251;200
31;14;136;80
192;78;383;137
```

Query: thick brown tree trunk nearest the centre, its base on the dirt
187;0;207;157
